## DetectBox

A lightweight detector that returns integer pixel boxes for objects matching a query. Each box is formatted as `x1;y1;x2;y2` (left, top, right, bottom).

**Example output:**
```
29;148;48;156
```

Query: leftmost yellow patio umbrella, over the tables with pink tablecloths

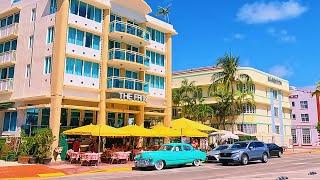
63;124;128;137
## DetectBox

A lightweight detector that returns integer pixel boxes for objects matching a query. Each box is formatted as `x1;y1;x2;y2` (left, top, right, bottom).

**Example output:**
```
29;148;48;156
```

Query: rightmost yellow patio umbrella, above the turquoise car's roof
171;118;219;131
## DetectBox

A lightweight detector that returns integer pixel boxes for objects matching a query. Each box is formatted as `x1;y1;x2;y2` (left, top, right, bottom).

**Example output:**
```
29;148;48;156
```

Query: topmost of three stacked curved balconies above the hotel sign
110;21;150;46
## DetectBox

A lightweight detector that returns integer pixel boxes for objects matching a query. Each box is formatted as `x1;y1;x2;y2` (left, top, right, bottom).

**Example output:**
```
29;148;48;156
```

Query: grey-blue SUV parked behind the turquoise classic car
219;141;269;165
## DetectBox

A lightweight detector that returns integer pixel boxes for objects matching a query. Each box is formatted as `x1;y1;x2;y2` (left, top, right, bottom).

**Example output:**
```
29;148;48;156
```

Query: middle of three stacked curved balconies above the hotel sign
108;49;150;70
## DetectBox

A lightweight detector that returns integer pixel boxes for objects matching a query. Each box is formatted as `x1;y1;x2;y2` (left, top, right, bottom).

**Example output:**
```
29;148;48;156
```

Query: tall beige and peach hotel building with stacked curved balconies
0;0;177;145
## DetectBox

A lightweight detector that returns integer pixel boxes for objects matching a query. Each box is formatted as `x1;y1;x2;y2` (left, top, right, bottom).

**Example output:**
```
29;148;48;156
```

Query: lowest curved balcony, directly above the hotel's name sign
107;76;149;93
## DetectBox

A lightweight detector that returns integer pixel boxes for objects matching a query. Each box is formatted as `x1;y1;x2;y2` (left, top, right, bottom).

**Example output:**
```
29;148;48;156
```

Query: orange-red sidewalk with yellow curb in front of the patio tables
0;162;133;179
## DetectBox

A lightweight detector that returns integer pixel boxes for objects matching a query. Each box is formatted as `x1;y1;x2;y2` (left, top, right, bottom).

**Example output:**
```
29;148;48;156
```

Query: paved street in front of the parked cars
52;153;320;180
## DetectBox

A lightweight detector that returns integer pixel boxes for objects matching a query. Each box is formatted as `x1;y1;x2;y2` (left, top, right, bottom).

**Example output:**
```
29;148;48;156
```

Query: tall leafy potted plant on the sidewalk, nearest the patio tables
34;128;55;164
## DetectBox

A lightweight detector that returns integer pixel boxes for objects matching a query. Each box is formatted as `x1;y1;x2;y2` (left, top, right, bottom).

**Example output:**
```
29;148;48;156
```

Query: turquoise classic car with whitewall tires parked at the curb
134;143;206;170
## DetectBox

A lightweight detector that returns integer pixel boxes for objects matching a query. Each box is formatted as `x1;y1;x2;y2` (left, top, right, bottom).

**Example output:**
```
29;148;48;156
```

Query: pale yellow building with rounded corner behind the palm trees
172;67;292;146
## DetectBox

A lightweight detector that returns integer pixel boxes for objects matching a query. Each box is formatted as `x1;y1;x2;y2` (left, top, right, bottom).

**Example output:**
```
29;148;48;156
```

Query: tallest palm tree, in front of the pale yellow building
209;54;252;131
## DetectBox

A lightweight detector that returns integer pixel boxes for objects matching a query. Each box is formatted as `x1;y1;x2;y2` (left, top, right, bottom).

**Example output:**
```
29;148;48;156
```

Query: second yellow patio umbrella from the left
119;125;158;137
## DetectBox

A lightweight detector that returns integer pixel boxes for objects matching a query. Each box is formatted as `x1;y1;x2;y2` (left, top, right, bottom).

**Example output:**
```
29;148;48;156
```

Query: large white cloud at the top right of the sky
237;0;308;24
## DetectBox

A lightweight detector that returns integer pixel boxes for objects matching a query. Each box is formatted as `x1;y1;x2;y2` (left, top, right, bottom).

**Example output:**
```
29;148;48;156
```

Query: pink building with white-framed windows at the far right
290;88;320;147
